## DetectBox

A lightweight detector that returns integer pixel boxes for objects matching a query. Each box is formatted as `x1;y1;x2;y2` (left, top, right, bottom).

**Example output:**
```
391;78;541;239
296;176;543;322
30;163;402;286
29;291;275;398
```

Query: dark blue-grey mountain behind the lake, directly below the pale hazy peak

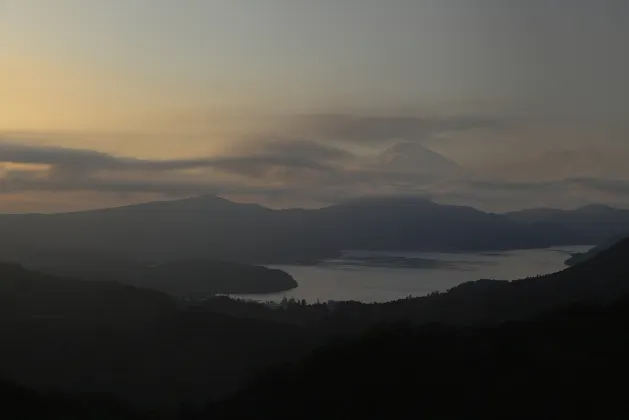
315;197;580;251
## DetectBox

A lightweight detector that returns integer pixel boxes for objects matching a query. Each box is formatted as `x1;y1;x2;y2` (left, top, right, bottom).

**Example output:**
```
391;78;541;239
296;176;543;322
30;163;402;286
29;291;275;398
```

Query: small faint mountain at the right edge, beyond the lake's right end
506;205;629;245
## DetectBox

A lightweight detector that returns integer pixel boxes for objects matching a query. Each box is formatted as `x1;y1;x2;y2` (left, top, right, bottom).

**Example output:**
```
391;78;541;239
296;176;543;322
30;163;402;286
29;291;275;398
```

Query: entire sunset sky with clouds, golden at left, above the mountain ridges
0;0;629;212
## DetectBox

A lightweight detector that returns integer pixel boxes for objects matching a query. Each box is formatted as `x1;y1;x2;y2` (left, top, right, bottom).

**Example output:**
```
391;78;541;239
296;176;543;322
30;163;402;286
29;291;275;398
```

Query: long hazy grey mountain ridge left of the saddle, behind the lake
0;196;338;264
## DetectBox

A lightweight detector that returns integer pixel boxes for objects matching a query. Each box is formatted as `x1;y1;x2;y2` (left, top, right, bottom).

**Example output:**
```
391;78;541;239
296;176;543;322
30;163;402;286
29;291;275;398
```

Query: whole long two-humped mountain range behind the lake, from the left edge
0;196;587;264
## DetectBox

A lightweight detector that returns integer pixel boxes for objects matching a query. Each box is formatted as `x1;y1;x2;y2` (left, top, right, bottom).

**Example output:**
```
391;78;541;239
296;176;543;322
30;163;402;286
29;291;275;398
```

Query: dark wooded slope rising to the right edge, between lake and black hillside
391;235;629;325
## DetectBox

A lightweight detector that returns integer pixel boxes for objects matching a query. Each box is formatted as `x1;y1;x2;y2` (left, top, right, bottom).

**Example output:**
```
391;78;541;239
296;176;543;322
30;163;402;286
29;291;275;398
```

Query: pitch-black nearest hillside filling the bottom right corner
210;300;629;420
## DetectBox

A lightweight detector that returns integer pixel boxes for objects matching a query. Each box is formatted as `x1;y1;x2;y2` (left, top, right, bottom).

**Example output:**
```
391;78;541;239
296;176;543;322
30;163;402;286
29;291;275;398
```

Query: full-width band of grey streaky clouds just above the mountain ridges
0;115;629;211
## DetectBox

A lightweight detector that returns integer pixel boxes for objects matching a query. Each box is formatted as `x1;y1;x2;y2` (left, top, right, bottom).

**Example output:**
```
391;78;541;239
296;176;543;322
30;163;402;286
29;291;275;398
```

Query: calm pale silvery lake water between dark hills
238;246;590;302
